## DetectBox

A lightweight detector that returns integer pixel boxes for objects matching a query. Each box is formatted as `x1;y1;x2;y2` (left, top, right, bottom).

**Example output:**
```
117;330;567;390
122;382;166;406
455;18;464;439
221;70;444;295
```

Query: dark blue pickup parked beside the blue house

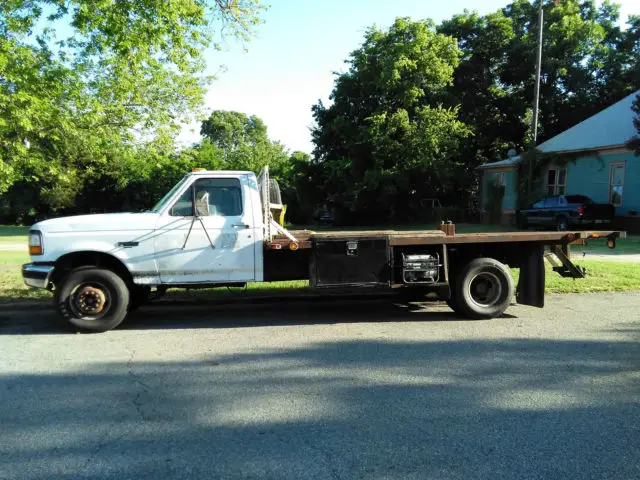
516;195;616;231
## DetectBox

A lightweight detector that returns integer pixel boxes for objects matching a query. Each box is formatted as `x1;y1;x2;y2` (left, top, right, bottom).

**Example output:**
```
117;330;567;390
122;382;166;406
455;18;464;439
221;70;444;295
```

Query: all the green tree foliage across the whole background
0;0;640;224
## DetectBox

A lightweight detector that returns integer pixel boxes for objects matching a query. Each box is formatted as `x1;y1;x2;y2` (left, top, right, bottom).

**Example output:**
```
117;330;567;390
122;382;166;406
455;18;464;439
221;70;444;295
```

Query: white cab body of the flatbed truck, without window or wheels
31;171;264;285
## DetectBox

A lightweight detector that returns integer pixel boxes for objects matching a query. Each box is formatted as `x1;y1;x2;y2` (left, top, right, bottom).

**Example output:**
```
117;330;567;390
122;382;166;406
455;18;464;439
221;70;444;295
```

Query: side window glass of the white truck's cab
171;178;242;217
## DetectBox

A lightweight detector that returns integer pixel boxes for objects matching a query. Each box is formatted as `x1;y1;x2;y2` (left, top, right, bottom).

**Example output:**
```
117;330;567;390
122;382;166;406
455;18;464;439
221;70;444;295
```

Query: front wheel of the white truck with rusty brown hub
55;268;130;332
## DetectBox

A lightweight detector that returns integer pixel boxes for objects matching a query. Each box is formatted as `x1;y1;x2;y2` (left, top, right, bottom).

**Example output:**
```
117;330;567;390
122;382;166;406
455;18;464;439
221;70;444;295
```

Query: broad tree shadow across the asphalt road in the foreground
0;336;640;480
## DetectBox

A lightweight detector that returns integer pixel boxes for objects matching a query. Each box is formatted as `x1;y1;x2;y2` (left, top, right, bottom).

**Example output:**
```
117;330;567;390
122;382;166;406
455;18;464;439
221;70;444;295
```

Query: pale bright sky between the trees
179;0;640;153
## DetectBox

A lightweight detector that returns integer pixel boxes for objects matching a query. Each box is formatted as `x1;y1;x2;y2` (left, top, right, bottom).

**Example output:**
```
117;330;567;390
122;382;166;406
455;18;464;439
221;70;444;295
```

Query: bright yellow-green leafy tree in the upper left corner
0;0;262;220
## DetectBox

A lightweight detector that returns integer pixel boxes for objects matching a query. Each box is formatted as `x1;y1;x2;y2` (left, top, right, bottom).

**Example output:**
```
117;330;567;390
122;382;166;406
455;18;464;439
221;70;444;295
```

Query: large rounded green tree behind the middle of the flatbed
312;18;469;222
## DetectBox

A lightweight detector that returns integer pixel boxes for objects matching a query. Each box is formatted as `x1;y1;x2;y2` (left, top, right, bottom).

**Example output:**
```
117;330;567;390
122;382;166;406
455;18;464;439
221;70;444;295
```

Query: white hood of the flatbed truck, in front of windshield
31;212;158;233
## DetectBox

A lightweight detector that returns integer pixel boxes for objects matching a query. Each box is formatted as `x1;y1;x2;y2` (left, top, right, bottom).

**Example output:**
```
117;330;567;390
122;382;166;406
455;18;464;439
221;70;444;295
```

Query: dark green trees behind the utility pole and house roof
438;0;640;204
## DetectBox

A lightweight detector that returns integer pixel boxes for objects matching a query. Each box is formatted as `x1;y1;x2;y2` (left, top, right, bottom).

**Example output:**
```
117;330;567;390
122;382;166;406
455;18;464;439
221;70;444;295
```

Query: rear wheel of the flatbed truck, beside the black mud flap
452;258;514;320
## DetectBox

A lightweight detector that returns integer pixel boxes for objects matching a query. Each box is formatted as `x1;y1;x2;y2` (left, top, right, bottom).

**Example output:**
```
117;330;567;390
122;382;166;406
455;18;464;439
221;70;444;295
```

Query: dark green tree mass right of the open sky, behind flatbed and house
311;0;640;221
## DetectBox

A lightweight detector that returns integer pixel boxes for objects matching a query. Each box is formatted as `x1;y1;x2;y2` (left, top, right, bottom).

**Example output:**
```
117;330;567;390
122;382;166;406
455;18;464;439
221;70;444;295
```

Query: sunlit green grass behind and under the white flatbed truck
0;246;640;304
